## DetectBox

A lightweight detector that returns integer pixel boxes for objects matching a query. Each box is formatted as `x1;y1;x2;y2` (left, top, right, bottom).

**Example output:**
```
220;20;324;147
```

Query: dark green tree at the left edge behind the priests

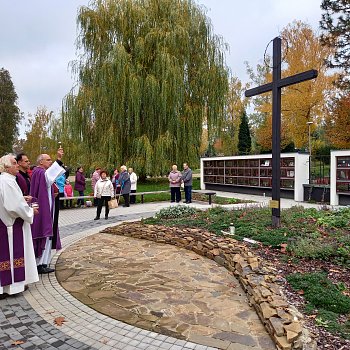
0;68;21;156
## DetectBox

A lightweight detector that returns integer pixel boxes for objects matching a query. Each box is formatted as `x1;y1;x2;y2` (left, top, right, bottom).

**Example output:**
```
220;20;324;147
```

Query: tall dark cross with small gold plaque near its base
245;37;318;227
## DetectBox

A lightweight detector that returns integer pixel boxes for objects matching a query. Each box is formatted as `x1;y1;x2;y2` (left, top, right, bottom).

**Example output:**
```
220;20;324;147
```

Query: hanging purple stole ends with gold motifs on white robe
0;218;25;287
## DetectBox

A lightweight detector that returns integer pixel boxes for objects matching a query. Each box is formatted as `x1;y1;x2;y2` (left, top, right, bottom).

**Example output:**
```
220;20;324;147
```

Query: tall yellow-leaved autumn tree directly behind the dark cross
252;21;336;149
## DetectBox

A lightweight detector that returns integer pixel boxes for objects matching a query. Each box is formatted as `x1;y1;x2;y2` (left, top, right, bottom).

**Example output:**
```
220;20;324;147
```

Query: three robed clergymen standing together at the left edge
0;148;66;297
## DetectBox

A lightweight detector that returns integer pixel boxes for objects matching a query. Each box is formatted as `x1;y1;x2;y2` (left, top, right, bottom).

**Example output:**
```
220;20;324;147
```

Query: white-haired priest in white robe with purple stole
0;155;39;297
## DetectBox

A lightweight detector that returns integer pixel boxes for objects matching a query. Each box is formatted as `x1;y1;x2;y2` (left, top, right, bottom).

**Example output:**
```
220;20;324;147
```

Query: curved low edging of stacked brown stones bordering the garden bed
102;222;317;350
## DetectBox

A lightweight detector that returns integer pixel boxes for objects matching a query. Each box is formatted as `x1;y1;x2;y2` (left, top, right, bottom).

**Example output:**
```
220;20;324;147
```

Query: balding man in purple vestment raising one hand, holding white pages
30;148;66;273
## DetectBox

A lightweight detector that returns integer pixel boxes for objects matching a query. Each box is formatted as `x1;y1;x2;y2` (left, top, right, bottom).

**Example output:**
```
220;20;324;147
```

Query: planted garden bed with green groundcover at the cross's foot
145;207;350;350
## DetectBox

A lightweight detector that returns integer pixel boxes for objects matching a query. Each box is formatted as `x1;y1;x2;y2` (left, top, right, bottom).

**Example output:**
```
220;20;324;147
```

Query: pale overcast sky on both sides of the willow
0;0;321;133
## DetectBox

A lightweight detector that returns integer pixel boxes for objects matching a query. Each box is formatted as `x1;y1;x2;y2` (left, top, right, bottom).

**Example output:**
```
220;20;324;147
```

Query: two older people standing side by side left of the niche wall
168;163;192;204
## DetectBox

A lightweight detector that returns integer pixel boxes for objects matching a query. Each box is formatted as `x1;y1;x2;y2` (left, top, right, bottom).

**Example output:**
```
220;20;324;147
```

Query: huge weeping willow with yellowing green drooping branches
63;0;228;174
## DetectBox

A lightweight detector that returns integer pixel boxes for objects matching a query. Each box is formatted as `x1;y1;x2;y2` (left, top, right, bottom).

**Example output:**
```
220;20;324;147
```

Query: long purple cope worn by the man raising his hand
30;167;61;258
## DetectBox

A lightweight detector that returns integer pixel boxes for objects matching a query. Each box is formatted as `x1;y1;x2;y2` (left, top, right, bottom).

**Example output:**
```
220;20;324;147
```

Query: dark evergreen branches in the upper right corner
320;0;350;89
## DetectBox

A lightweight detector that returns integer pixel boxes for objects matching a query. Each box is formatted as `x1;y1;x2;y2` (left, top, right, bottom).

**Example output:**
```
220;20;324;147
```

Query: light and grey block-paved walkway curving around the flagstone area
0;193;334;350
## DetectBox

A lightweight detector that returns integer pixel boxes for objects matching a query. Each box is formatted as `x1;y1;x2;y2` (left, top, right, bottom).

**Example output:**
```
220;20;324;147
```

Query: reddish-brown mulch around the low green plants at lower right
250;243;350;350
